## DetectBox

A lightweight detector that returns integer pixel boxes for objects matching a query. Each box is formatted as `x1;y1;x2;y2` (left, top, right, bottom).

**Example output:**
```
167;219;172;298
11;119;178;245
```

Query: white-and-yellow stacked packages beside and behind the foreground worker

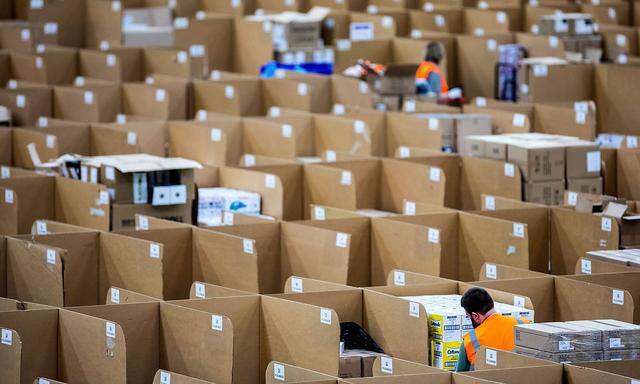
403;295;534;371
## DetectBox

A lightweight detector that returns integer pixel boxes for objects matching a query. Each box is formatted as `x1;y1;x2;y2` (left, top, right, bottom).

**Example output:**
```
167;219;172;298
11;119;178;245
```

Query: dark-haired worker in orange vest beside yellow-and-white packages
456;288;528;372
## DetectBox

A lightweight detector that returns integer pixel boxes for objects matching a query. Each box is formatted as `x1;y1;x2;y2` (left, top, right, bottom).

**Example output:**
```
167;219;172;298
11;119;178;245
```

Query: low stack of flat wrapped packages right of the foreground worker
515;320;640;363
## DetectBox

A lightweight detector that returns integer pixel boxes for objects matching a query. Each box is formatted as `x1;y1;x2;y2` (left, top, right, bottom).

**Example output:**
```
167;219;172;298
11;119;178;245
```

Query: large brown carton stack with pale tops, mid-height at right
467;133;602;205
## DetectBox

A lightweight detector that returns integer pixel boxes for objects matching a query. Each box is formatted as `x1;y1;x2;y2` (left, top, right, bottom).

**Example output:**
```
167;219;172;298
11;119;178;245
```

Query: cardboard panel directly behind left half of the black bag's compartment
281;217;371;287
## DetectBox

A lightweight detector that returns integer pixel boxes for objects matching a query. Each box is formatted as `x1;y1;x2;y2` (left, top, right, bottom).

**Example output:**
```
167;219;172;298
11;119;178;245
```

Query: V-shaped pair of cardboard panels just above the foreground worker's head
371;212;529;285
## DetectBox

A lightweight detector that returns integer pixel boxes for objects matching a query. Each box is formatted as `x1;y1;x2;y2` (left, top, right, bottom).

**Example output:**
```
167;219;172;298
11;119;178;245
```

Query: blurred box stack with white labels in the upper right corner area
536;13;602;61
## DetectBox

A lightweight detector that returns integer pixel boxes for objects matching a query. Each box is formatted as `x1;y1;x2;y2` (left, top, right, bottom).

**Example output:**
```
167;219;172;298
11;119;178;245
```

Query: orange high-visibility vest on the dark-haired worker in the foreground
463;313;527;367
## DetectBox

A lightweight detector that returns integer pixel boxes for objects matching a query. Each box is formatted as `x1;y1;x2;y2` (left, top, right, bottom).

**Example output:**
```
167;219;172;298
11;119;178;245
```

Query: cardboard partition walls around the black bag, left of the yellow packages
260;289;428;377
